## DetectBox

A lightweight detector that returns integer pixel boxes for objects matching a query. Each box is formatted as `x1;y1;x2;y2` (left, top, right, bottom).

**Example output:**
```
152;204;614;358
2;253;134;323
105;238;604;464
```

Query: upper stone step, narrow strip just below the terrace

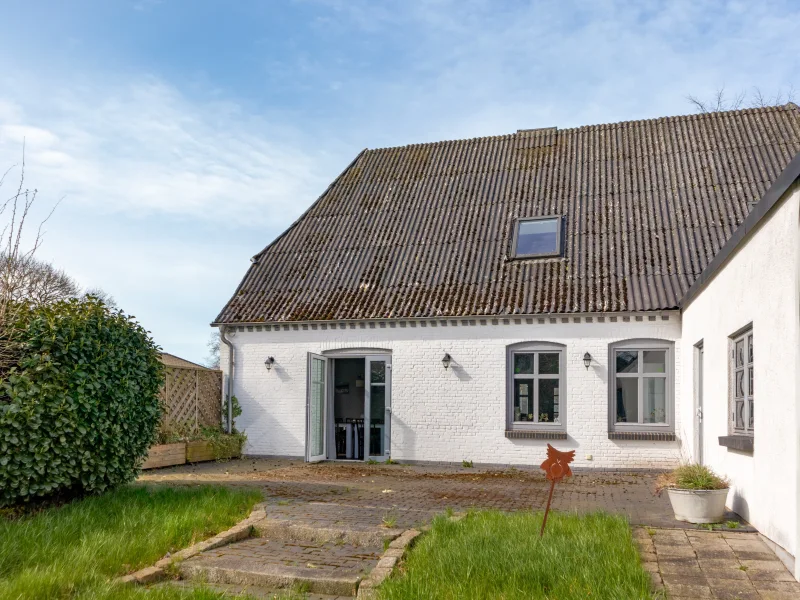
253;518;403;546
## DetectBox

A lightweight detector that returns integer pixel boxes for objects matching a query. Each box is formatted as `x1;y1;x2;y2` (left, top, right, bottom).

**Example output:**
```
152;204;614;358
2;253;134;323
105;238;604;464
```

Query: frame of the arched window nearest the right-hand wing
608;339;675;433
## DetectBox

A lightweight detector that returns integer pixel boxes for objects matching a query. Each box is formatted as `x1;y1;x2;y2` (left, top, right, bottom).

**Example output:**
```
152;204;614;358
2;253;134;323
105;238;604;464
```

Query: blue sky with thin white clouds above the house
0;0;800;360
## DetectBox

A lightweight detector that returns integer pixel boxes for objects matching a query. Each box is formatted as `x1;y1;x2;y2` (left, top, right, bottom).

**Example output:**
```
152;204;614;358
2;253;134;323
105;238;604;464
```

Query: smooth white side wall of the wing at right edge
681;183;800;554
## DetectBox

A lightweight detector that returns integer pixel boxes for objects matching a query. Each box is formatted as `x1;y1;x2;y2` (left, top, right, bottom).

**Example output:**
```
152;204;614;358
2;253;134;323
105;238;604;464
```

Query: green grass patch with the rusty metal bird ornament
380;511;651;600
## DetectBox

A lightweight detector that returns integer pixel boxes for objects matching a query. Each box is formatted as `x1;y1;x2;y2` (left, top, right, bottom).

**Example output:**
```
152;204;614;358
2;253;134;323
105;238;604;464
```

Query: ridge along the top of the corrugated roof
366;102;800;153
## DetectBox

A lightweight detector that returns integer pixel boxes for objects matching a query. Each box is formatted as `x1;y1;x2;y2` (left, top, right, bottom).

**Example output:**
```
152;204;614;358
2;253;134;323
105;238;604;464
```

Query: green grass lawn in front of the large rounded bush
0;486;261;600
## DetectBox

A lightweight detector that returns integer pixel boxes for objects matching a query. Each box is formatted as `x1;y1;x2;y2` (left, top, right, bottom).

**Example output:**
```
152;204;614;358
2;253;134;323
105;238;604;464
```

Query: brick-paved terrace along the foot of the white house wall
139;458;738;529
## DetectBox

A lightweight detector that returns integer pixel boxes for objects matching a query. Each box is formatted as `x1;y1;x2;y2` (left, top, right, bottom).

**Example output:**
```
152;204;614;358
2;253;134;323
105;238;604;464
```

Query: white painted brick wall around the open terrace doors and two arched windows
222;312;681;468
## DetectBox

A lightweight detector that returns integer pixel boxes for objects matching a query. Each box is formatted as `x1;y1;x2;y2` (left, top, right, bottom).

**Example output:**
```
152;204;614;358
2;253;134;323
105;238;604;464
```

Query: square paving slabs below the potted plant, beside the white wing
634;528;800;600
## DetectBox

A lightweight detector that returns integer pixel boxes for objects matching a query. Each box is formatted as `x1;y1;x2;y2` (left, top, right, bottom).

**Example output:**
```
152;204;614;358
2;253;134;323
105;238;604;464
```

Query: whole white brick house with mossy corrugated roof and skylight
214;103;800;576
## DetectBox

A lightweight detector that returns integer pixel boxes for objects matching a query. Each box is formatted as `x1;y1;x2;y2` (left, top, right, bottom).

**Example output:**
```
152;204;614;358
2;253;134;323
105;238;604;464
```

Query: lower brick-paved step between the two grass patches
179;538;383;597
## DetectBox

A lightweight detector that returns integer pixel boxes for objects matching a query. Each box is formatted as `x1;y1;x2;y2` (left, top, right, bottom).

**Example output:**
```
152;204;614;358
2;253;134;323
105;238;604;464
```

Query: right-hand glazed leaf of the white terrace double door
364;356;392;460
